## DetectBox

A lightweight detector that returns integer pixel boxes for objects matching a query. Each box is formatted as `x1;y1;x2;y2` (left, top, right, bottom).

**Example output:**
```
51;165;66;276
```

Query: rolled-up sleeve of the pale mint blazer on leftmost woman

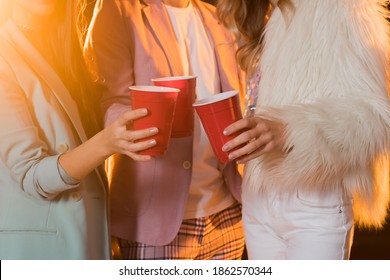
0;56;78;199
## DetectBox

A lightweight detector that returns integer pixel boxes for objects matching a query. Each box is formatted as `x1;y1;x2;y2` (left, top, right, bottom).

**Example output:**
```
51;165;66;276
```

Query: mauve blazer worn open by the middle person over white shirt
85;0;243;245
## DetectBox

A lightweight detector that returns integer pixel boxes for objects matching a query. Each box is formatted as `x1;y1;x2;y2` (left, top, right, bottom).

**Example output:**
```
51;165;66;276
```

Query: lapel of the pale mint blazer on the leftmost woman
4;21;87;142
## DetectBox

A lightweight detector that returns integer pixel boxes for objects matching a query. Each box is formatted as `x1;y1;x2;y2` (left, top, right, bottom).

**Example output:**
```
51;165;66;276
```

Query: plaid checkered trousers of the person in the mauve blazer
118;204;245;260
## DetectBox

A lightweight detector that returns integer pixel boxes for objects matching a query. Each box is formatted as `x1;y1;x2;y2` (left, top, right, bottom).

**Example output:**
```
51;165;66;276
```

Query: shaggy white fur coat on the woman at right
244;0;390;226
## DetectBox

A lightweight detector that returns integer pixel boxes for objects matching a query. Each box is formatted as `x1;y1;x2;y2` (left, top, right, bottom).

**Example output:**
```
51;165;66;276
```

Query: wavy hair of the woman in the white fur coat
217;0;294;77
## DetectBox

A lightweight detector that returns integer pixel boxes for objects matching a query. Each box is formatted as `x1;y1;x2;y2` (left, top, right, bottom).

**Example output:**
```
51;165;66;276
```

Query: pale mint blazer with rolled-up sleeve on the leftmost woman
0;21;111;259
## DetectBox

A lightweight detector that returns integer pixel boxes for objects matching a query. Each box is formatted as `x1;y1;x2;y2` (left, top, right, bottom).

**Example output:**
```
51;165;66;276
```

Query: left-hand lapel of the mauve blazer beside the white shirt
143;0;184;76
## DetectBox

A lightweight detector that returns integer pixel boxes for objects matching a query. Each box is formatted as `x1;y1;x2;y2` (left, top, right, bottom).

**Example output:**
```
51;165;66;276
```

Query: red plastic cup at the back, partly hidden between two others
152;76;196;138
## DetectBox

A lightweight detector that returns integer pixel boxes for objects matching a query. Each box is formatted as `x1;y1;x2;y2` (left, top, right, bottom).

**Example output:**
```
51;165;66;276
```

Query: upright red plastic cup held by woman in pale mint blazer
129;86;179;156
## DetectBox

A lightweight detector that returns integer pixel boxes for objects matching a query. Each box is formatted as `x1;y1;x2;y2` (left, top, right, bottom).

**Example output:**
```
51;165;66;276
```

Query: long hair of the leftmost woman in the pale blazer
0;0;101;137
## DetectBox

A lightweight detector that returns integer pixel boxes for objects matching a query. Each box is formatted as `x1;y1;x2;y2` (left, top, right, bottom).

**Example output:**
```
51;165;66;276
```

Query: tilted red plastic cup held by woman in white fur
193;90;242;162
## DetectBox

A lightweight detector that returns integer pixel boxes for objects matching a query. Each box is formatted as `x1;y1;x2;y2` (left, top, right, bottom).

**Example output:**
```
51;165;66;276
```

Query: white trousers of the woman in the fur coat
243;188;354;260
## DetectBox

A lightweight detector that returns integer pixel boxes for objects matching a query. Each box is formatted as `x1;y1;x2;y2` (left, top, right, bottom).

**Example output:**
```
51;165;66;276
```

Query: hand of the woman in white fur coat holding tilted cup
222;116;285;163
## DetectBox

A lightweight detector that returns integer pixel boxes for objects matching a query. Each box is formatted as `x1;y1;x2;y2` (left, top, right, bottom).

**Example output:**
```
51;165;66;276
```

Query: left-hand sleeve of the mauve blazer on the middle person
84;0;134;124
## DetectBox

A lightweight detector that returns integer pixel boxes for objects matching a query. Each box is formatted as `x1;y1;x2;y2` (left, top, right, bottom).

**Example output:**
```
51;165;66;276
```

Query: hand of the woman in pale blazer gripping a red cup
101;109;158;161
